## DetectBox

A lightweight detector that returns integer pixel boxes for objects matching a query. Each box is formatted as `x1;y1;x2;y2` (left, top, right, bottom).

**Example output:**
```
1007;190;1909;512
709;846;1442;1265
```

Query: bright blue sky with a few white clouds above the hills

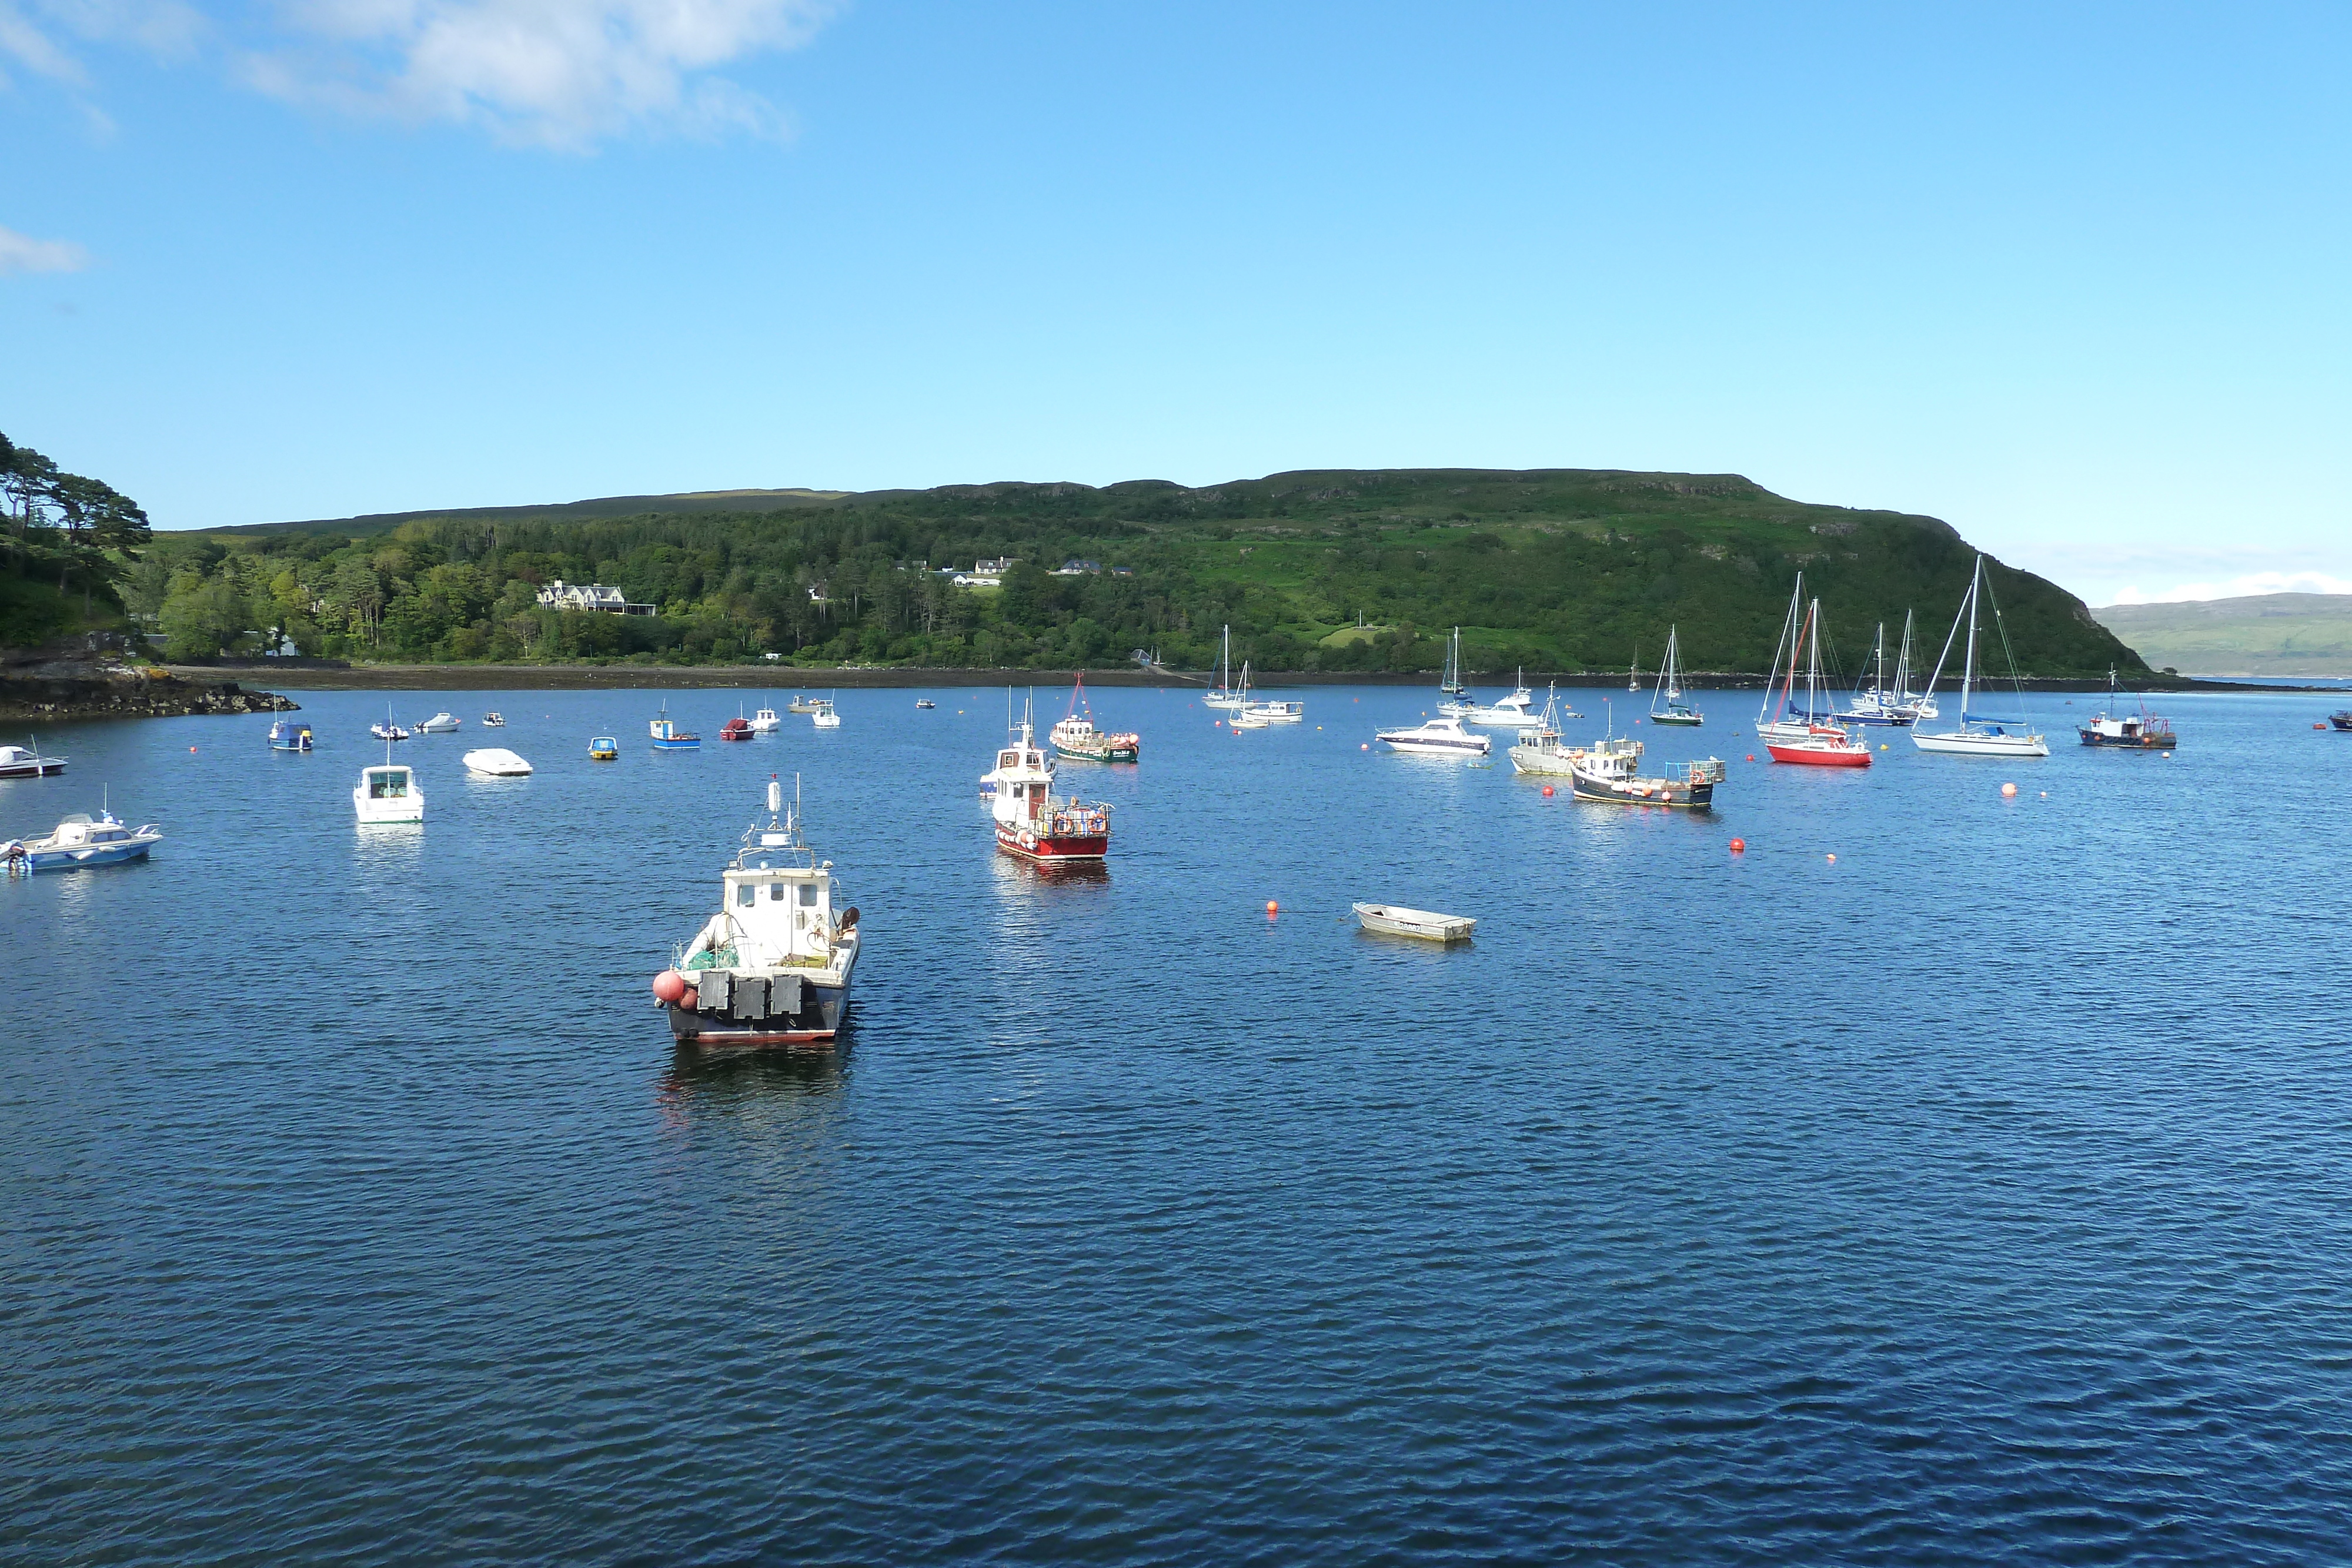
0;0;2352;604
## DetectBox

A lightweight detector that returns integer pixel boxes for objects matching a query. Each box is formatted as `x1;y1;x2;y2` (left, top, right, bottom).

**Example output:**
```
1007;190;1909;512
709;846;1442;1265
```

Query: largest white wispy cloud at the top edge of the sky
245;0;833;148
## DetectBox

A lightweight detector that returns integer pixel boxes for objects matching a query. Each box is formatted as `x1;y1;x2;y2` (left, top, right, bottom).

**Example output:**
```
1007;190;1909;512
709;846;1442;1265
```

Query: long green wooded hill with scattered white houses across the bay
55;470;2143;675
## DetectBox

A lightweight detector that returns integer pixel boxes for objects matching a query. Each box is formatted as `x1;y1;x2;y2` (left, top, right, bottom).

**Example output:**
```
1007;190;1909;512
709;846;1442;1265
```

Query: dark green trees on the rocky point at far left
0;435;148;649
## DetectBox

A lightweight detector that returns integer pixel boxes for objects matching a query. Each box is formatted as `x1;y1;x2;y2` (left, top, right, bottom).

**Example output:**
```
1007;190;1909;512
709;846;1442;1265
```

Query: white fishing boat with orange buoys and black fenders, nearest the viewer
654;778;858;1046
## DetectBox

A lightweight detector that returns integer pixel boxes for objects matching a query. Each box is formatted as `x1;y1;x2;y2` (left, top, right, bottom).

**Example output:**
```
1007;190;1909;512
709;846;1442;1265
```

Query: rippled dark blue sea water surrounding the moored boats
0;689;2352;1563
